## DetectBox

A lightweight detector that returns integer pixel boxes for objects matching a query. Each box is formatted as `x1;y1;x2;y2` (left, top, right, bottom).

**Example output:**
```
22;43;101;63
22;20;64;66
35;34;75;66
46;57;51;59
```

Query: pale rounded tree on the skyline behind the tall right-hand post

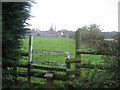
78;24;104;43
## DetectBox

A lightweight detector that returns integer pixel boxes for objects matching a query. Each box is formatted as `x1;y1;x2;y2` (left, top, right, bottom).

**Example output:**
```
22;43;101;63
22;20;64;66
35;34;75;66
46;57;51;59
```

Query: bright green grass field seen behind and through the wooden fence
18;37;102;86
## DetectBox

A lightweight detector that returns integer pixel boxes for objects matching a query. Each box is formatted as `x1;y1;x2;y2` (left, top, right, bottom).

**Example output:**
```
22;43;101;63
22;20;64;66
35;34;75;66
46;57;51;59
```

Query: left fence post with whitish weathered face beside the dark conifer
27;35;33;84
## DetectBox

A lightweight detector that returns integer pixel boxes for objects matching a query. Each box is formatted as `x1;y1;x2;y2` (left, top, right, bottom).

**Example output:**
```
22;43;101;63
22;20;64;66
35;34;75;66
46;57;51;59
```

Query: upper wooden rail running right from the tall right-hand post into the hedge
77;49;112;55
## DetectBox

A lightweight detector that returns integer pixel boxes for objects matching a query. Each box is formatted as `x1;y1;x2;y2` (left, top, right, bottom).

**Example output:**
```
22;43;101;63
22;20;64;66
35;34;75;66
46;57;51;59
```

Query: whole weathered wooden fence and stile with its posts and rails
13;31;110;87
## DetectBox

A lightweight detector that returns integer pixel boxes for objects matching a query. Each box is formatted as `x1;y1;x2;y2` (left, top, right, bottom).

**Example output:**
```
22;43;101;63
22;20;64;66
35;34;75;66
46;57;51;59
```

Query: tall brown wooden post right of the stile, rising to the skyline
75;31;81;78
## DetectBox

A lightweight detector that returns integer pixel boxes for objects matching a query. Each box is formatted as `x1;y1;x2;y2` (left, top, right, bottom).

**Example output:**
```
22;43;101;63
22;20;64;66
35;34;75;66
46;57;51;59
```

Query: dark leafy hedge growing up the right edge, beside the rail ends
83;33;120;87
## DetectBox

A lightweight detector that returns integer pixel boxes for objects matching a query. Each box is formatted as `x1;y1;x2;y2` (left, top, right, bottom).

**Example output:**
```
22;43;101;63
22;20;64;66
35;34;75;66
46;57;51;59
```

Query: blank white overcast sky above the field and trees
28;0;120;31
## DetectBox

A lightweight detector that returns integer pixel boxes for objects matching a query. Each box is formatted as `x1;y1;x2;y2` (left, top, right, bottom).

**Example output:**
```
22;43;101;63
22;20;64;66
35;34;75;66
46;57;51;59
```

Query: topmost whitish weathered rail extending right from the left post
32;50;70;55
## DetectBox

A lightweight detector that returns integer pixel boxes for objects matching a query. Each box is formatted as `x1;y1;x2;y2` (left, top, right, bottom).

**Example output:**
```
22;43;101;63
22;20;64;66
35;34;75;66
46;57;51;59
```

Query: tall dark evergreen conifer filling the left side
2;2;31;86
